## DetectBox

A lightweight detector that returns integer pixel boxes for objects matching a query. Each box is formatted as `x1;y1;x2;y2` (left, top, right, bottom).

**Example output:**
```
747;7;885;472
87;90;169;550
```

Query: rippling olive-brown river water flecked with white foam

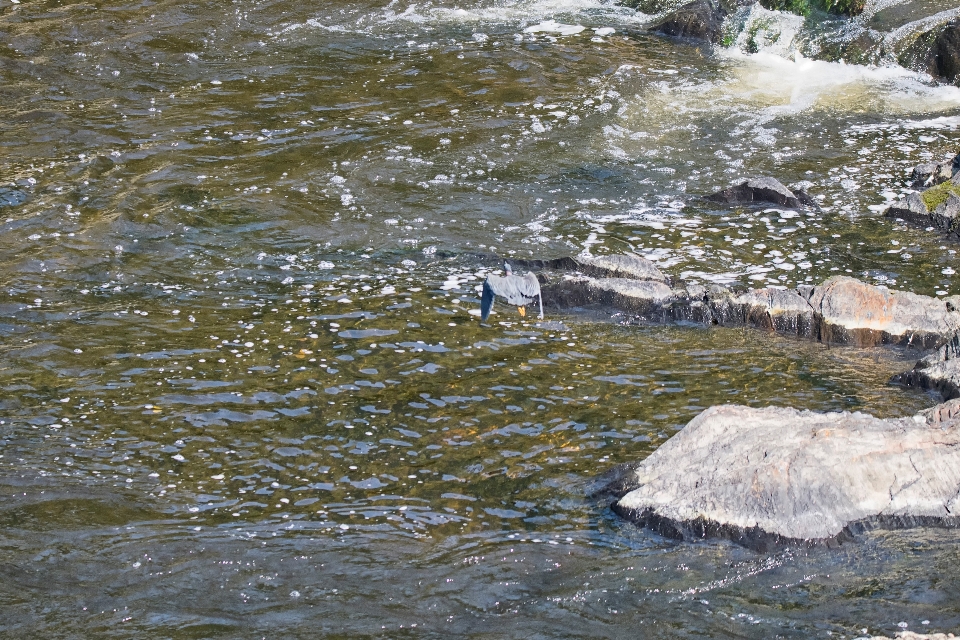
0;0;960;638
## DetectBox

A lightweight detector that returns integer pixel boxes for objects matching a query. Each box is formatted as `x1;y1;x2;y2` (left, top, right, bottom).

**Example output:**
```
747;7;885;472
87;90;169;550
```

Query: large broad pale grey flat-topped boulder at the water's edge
613;405;960;550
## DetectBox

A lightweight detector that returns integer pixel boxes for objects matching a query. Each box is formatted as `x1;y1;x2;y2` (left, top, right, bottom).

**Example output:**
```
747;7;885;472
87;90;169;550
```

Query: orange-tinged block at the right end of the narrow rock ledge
810;276;960;348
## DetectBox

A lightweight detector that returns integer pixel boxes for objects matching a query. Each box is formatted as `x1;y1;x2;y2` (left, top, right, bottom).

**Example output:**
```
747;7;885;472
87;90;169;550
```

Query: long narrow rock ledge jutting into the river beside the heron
515;254;960;349
